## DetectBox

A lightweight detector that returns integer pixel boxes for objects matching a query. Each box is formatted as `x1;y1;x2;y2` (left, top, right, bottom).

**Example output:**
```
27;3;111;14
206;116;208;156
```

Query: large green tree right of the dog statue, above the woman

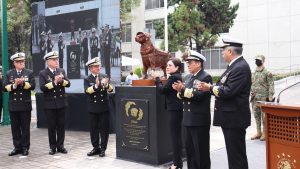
165;0;239;51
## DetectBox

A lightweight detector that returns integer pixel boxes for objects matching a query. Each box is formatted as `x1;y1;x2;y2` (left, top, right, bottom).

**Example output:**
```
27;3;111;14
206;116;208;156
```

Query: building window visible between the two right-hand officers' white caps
201;48;227;69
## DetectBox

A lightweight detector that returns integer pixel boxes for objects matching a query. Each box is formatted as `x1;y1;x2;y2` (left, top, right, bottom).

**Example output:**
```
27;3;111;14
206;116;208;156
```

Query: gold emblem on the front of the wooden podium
277;153;297;169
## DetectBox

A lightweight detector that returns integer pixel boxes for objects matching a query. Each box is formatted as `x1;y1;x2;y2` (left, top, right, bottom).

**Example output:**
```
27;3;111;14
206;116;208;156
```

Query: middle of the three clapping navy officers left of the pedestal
39;51;71;155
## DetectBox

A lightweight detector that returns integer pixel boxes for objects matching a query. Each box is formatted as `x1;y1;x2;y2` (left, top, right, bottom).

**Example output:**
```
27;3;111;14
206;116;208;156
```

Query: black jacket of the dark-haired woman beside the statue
155;73;182;110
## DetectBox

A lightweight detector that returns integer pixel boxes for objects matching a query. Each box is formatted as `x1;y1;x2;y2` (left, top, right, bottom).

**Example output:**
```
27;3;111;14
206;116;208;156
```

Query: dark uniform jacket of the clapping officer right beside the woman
179;69;212;126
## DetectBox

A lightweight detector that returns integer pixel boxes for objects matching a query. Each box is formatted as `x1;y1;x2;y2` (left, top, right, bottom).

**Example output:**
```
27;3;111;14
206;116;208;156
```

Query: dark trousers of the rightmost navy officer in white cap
222;127;248;169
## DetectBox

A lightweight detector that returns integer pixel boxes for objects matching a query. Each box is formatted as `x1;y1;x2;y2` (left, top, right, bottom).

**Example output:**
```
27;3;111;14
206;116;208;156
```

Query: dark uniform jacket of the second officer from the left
39;68;71;109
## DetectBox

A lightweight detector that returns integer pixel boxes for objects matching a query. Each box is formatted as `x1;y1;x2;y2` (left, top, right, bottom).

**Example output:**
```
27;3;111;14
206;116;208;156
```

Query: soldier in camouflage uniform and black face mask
251;55;274;141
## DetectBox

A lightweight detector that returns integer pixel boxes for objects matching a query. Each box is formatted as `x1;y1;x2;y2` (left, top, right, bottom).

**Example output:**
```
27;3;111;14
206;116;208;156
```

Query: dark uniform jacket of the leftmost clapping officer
3;69;35;111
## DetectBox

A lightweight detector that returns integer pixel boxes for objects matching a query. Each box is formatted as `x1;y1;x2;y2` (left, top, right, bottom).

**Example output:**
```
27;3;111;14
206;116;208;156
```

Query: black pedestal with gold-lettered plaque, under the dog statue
115;86;172;165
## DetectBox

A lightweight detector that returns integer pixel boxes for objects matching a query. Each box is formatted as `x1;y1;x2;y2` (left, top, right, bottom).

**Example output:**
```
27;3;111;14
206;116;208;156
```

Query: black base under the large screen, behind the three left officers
36;93;116;133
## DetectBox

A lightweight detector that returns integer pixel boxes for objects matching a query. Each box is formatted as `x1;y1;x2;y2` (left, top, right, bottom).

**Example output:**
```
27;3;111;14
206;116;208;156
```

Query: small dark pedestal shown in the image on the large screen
67;45;80;79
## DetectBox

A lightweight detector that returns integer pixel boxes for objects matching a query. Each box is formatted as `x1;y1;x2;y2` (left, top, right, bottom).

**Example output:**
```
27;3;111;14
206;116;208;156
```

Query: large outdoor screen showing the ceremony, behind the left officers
32;0;121;92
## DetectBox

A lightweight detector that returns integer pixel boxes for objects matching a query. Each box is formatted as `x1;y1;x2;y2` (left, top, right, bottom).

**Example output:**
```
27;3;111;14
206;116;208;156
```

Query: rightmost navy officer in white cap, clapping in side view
198;37;251;169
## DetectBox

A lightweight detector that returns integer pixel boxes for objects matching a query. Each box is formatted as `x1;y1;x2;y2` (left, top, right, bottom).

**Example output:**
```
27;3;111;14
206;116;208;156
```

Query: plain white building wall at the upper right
230;0;300;72
